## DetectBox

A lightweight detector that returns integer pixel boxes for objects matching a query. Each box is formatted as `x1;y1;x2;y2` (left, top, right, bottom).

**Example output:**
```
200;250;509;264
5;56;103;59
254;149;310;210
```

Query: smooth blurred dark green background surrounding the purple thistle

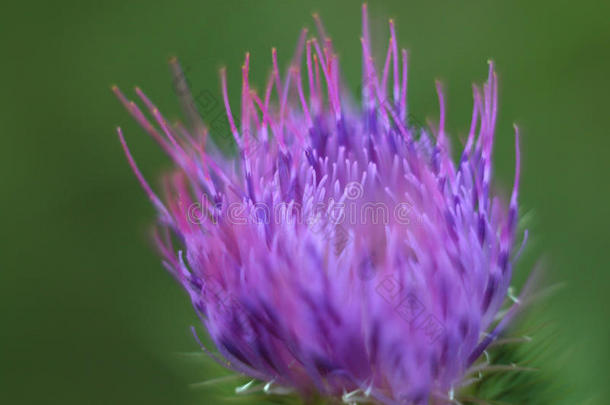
0;0;610;404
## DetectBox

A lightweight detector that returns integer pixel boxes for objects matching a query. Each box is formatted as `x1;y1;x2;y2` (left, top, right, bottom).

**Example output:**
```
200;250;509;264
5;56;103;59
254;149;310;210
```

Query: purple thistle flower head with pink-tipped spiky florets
114;6;519;404
